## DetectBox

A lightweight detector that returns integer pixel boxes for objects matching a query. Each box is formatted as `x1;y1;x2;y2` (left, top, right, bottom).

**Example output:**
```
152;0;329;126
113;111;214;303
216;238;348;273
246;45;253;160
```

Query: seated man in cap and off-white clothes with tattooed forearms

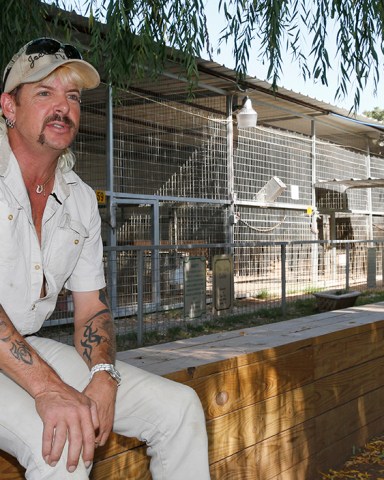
0;38;209;480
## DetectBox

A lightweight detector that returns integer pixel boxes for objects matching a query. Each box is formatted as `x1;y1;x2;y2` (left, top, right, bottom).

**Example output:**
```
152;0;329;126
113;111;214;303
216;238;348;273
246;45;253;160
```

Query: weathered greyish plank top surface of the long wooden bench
118;304;384;382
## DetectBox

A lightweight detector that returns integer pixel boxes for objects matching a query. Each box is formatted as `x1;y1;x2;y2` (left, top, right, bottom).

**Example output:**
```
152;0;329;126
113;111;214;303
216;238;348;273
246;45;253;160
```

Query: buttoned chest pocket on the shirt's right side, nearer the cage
48;214;89;280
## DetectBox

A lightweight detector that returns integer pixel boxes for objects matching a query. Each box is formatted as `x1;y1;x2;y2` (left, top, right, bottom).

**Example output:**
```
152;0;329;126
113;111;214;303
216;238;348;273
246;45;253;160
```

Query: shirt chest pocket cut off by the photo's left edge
0;203;22;266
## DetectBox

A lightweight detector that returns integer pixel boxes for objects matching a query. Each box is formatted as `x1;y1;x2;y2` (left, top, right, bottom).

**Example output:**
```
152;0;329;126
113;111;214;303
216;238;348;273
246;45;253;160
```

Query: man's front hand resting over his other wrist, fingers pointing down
35;384;99;472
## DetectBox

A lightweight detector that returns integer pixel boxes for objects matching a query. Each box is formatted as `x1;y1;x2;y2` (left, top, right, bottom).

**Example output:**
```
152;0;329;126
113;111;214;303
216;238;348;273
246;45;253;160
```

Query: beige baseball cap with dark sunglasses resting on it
3;37;100;93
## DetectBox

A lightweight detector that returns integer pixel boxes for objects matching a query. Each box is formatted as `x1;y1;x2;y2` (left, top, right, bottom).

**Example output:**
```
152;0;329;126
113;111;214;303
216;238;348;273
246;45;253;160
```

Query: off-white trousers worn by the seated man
0;337;210;480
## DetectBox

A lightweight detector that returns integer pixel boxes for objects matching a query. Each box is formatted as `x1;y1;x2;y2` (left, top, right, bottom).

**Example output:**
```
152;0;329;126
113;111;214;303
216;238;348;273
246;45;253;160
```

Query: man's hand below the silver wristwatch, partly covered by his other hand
83;372;117;447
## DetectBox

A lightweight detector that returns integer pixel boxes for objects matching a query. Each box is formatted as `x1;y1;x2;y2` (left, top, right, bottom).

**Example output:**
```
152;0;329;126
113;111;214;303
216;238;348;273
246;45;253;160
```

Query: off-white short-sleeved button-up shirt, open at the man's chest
0;131;105;335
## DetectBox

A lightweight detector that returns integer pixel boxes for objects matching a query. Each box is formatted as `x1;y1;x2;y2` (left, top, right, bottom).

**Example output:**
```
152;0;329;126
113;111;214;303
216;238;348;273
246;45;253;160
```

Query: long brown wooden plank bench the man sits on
0;304;384;480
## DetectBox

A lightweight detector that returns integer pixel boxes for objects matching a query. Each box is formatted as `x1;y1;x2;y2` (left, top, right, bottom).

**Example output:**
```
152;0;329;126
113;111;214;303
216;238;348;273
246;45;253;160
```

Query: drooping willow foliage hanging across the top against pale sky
0;0;384;109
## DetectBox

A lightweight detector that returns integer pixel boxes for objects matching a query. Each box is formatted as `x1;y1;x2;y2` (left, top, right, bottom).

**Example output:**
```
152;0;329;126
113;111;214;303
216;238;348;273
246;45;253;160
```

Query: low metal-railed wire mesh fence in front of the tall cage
44;241;383;349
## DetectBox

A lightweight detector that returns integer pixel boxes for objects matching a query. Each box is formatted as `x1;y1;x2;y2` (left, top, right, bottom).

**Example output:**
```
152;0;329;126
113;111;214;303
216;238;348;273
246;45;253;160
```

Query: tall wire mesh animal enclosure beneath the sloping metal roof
45;80;384;348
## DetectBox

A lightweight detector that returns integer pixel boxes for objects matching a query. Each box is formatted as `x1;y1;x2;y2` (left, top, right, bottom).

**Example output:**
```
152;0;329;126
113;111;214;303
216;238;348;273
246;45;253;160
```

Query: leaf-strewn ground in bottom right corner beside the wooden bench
321;434;384;480
